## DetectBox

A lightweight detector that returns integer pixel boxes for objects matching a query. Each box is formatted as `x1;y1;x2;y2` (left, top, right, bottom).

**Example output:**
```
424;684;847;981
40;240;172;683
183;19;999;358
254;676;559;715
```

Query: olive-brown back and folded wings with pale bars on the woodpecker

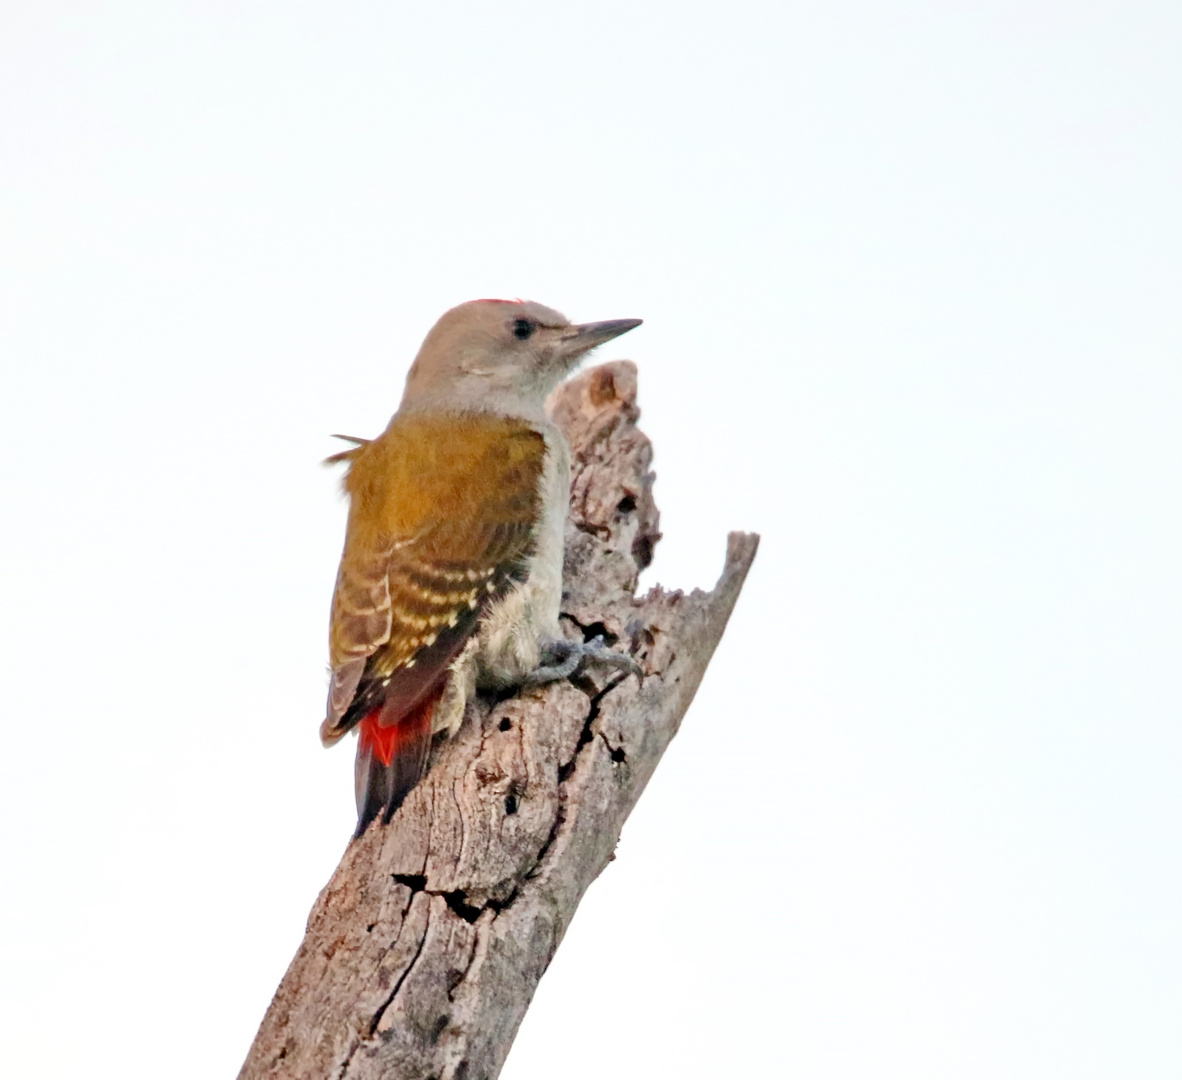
320;414;546;743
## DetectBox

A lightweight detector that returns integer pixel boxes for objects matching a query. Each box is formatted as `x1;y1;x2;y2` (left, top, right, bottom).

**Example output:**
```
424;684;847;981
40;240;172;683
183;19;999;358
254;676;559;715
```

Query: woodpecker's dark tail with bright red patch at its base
353;692;440;838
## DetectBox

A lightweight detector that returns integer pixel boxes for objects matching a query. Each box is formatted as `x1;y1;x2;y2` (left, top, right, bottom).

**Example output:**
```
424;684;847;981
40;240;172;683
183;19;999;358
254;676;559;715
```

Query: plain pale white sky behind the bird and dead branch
0;0;1182;1080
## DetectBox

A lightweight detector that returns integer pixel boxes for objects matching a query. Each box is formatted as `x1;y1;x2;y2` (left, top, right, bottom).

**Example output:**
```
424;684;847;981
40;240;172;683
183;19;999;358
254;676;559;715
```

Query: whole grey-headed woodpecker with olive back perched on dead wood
320;300;641;835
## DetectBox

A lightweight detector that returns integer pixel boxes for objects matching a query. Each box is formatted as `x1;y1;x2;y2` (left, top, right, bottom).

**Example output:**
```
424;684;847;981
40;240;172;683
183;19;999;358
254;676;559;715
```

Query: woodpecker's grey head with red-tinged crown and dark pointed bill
402;300;641;417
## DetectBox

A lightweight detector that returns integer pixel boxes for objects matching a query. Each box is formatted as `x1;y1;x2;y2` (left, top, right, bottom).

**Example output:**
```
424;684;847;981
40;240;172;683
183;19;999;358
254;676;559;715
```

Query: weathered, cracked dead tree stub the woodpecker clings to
239;362;758;1080
